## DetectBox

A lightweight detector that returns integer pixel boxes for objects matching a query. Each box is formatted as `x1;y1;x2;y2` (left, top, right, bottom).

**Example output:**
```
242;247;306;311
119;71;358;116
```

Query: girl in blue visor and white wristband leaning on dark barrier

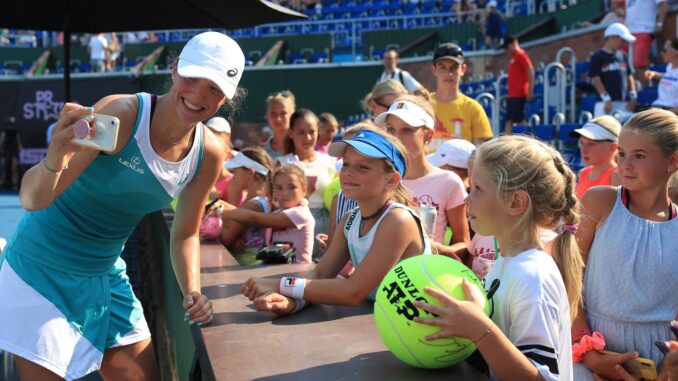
242;130;429;314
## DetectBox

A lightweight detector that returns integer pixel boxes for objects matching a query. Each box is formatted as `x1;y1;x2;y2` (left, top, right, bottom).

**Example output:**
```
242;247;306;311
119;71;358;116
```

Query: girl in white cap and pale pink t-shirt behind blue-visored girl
374;95;471;260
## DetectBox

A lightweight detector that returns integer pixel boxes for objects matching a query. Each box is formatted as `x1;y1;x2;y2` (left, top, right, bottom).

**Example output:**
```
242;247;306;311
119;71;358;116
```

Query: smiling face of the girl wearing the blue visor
339;147;392;201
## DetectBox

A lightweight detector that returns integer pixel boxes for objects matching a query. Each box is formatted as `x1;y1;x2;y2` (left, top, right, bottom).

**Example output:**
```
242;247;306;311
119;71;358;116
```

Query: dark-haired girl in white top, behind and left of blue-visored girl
277;108;337;257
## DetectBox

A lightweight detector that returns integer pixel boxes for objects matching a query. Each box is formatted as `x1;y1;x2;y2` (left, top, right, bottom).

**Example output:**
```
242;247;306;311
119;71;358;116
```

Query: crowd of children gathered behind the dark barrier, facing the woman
190;72;678;380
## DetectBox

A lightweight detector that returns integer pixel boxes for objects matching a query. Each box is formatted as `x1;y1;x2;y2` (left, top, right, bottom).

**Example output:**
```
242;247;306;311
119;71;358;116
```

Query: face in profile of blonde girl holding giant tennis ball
464;165;511;235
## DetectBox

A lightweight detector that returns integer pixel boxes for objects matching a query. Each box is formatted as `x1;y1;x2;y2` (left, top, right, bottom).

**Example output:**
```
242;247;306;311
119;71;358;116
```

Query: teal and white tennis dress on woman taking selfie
0;93;204;380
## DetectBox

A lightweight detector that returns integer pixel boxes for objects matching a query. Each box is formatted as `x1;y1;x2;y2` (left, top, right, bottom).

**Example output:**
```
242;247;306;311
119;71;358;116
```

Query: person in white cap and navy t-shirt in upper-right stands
589;23;638;116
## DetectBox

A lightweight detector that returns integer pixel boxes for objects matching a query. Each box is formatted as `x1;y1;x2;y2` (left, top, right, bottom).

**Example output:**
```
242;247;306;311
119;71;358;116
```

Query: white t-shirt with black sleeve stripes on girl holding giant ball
485;249;572;381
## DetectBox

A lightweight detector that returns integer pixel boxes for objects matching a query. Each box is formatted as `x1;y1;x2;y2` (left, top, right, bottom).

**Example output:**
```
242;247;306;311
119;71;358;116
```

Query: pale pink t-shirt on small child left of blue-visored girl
271;200;315;263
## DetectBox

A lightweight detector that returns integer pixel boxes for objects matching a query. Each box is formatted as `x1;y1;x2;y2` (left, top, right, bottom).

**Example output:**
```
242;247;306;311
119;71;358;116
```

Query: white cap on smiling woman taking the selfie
177;32;245;99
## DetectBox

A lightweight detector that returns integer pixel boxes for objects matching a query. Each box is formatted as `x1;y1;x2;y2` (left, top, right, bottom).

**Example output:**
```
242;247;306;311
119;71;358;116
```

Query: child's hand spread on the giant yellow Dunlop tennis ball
414;279;491;340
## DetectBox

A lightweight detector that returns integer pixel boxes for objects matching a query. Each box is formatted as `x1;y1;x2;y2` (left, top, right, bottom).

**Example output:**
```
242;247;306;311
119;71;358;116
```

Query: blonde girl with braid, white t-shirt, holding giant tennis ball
415;135;582;380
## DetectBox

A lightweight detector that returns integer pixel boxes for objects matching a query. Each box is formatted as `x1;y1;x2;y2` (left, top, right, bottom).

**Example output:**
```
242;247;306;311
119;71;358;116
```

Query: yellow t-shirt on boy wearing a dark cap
431;93;492;142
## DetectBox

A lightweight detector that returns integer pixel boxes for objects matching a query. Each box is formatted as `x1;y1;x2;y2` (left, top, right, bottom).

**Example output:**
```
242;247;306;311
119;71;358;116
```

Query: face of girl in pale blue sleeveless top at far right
617;130;678;191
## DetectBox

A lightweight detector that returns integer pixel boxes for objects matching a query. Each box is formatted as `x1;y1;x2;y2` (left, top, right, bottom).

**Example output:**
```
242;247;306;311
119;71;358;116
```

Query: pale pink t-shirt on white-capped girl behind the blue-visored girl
403;167;466;243
